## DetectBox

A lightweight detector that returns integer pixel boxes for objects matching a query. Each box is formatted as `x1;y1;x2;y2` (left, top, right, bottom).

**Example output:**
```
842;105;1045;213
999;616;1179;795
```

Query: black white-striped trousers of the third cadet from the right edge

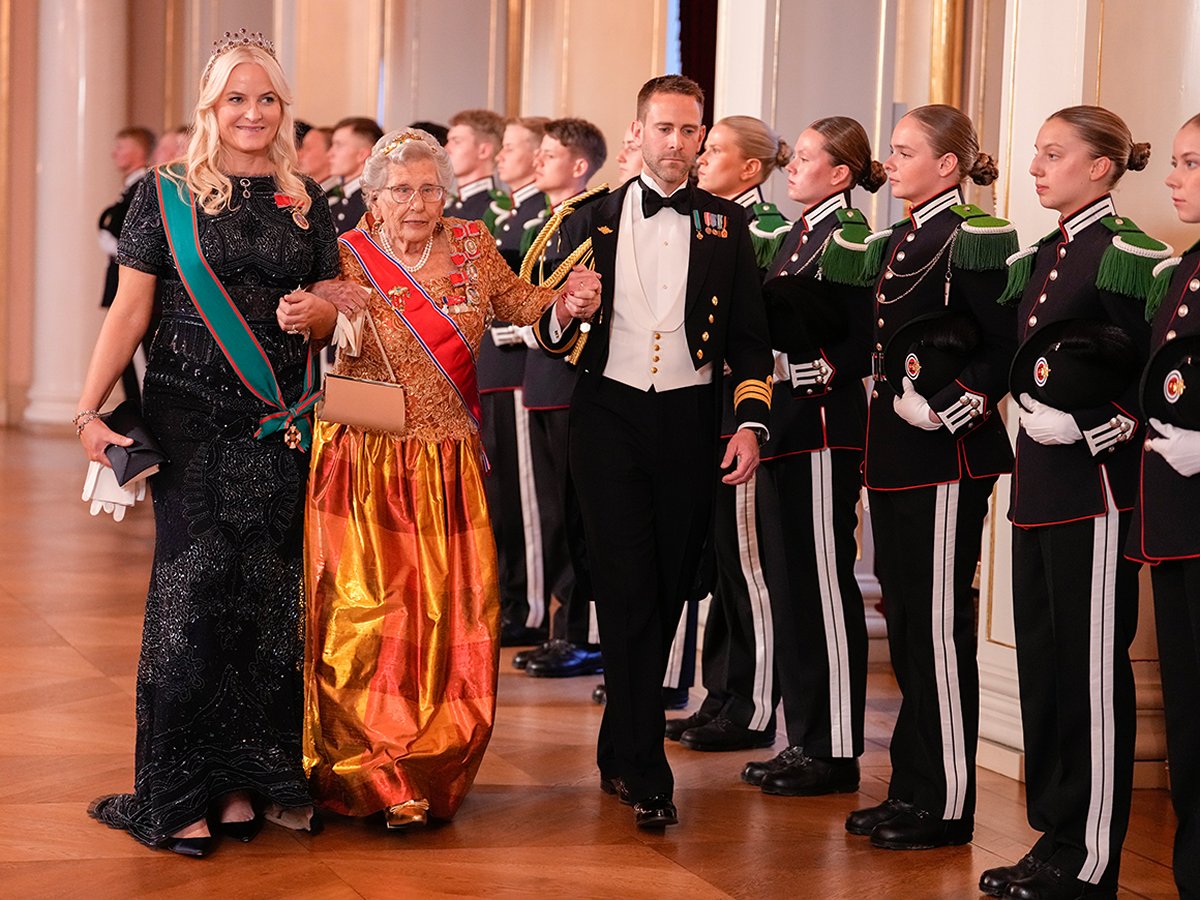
869;478;996;823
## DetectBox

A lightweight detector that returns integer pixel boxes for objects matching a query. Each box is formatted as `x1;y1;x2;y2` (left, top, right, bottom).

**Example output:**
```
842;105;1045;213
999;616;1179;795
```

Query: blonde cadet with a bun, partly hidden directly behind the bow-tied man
666;115;791;751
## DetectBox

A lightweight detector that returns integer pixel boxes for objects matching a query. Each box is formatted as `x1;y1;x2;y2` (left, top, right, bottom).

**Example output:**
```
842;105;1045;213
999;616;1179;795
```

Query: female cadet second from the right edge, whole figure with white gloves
980;107;1170;900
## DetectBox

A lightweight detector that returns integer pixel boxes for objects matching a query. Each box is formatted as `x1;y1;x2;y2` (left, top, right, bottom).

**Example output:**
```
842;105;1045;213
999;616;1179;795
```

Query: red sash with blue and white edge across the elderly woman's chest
337;228;481;428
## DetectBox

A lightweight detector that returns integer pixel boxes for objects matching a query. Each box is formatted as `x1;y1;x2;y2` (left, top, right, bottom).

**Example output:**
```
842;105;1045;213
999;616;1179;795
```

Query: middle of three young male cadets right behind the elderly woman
476;118;550;647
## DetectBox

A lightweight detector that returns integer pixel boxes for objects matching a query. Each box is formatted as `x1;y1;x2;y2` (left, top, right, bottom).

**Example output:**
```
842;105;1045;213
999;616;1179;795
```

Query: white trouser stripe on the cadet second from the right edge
1079;475;1121;884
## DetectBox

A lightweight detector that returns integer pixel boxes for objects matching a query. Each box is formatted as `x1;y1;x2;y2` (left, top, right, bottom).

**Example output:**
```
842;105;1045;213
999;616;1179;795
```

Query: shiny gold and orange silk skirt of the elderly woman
304;420;499;818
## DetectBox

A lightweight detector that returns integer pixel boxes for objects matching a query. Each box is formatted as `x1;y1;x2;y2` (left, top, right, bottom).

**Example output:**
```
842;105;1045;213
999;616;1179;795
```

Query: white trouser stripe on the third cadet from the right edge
931;481;967;818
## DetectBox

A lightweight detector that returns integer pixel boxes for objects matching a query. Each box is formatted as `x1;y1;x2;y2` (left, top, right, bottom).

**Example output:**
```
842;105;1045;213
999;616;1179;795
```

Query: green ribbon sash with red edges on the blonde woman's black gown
155;168;320;450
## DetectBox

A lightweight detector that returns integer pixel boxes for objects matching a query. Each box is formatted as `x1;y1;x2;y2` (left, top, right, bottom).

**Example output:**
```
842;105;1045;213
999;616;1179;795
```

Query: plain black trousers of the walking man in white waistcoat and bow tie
570;377;716;799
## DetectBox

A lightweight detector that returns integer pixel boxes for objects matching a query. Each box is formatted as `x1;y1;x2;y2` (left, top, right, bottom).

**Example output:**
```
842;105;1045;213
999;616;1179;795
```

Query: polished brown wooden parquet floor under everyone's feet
0;430;1175;900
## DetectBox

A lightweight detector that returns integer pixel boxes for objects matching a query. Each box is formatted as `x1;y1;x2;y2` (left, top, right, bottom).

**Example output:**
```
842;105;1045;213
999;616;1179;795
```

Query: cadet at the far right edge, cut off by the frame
1128;115;1200;898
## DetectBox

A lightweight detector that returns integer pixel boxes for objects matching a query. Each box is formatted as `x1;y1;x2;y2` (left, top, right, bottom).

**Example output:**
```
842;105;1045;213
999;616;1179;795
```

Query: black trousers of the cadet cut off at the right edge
1150;559;1200;898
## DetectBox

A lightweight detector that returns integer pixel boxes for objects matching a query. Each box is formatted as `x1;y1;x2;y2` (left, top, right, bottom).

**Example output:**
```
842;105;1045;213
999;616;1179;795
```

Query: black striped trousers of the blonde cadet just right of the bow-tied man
701;469;779;731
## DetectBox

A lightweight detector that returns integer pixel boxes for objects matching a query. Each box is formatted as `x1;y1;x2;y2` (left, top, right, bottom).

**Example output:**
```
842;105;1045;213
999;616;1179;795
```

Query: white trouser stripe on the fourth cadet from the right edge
809;450;854;756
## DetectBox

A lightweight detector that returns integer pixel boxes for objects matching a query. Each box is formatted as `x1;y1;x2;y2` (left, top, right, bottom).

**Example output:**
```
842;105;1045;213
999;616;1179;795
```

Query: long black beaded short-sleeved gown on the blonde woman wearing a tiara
89;173;338;846
